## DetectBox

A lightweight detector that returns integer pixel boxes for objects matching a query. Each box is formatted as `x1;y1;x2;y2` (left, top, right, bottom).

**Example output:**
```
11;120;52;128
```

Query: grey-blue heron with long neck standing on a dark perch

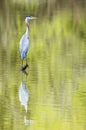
19;16;36;69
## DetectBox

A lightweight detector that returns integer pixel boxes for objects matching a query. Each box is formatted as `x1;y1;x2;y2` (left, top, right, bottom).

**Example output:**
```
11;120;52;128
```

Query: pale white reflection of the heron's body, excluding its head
19;81;29;112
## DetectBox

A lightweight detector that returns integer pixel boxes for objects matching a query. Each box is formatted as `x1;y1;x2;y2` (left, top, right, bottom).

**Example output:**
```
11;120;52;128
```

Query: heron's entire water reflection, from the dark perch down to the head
19;64;33;125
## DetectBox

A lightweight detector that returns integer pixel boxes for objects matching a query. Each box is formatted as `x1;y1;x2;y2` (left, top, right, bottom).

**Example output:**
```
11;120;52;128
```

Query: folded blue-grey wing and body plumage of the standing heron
20;34;29;59
